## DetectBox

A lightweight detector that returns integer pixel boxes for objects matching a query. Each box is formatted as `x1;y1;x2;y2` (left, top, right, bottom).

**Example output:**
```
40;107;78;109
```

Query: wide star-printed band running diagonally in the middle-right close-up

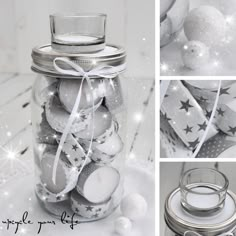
161;80;217;150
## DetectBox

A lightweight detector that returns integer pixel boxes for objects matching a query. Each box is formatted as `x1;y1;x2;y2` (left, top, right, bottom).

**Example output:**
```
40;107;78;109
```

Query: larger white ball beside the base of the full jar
120;193;147;220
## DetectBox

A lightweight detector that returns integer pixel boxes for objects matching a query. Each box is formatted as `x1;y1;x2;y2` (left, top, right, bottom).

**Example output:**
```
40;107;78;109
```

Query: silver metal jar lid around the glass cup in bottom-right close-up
165;188;236;236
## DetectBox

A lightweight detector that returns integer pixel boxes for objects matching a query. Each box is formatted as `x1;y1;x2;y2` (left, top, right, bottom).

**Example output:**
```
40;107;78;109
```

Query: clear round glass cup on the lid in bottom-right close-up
180;168;229;216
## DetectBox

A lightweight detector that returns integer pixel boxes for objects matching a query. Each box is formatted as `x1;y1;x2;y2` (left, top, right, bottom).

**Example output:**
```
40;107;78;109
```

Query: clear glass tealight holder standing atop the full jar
50;14;106;53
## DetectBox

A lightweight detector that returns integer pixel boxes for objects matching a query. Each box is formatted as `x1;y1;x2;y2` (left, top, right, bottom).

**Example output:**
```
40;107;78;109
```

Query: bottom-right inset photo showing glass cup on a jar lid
160;162;236;236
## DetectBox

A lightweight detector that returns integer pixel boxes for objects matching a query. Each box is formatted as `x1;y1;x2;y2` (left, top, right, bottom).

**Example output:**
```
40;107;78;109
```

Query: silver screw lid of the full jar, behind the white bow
31;45;126;78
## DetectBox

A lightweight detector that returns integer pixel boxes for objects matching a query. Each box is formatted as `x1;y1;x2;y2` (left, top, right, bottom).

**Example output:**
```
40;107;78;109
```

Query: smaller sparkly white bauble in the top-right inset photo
181;41;210;70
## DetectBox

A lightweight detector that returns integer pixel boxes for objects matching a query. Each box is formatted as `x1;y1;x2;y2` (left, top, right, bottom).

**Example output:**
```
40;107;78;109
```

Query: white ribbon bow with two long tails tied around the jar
52;57;126;184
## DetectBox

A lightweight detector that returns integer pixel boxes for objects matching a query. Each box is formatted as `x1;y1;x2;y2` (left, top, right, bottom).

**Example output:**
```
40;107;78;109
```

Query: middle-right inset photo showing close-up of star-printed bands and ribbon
160;79;236;158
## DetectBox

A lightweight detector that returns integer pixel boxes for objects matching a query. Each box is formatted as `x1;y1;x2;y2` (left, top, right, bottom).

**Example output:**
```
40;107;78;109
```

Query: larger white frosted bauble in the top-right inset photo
184;6;226;46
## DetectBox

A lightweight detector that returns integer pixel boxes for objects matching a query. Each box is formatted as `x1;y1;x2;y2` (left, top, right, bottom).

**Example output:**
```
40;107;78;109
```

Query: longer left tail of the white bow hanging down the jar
52;78;84;184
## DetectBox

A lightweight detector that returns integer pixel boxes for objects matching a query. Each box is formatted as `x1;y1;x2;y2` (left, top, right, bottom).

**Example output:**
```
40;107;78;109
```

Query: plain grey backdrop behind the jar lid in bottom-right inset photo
160;162;236;236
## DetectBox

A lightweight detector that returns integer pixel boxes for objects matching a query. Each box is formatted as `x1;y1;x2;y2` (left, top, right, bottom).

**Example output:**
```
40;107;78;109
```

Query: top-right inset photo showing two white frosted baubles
160;0;236;76
